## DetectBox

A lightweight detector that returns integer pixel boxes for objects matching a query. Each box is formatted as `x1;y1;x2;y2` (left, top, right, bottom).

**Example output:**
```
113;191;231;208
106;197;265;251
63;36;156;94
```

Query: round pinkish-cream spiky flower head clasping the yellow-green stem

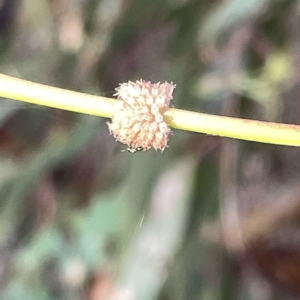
107;79;175;151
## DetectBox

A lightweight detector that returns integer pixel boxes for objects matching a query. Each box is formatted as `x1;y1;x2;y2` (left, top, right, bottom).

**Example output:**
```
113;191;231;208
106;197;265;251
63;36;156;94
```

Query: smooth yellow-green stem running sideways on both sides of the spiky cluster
0;74;300;146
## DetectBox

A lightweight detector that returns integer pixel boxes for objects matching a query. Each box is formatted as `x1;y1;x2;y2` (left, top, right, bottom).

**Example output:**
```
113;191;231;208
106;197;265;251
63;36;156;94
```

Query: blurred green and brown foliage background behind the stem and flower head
0;0;300;300
